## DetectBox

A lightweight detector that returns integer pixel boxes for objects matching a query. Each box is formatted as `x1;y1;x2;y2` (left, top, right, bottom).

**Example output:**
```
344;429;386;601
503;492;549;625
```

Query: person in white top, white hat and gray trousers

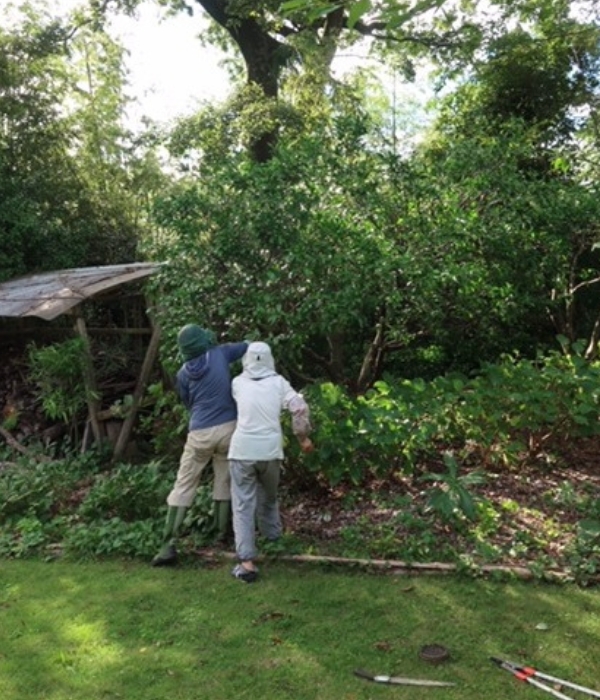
228;342;314;583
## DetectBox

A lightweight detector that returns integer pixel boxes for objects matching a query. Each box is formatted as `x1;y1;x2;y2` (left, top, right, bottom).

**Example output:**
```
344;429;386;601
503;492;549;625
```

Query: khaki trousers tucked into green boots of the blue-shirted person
167;421;235;507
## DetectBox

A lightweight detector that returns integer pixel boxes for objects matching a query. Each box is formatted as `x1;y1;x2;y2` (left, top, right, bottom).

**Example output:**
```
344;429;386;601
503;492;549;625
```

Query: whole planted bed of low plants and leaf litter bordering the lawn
0;348;600;585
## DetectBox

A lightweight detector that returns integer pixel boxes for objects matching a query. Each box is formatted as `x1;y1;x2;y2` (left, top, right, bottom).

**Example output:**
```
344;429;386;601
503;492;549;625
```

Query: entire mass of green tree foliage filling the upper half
0;0;600;392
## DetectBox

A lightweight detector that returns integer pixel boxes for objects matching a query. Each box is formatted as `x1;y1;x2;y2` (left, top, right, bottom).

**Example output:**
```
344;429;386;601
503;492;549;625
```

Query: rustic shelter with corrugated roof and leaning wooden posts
0;262;160;459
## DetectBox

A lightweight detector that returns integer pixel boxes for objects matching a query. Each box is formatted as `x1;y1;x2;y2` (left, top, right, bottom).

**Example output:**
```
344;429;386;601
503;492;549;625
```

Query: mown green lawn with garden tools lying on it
0;560;600;700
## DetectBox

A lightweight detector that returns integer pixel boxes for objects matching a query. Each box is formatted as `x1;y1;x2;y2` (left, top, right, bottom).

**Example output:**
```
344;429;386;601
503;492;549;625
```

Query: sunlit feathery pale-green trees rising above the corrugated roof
0;6;162;279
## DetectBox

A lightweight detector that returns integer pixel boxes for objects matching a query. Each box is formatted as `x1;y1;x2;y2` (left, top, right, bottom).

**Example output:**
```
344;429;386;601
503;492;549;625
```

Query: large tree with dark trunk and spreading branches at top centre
99;0;597;162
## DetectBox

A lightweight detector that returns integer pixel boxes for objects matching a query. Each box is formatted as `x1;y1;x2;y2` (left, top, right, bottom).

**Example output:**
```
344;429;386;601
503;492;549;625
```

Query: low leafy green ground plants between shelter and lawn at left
0;453;172;557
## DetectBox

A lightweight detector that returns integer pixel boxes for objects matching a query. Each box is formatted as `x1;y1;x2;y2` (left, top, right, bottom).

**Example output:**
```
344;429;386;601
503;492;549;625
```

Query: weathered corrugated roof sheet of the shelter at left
0;263;160;321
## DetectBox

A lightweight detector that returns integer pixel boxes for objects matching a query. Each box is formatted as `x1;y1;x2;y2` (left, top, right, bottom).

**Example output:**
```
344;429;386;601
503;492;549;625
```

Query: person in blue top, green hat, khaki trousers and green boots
152;324;248;566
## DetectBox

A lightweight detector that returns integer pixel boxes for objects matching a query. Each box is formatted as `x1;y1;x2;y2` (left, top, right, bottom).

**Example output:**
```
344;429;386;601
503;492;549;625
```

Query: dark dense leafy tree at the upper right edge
414;2;600;356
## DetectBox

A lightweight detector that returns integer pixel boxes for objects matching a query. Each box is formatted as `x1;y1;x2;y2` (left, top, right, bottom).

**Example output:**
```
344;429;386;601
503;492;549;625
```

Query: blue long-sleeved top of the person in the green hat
176;343;248;430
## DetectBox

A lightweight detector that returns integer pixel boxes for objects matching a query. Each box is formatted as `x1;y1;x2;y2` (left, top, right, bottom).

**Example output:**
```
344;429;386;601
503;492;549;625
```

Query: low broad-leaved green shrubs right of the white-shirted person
298;353;600;485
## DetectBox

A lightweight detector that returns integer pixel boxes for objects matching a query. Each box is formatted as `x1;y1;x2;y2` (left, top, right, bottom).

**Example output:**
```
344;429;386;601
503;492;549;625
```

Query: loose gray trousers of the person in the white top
229;459;282;561
